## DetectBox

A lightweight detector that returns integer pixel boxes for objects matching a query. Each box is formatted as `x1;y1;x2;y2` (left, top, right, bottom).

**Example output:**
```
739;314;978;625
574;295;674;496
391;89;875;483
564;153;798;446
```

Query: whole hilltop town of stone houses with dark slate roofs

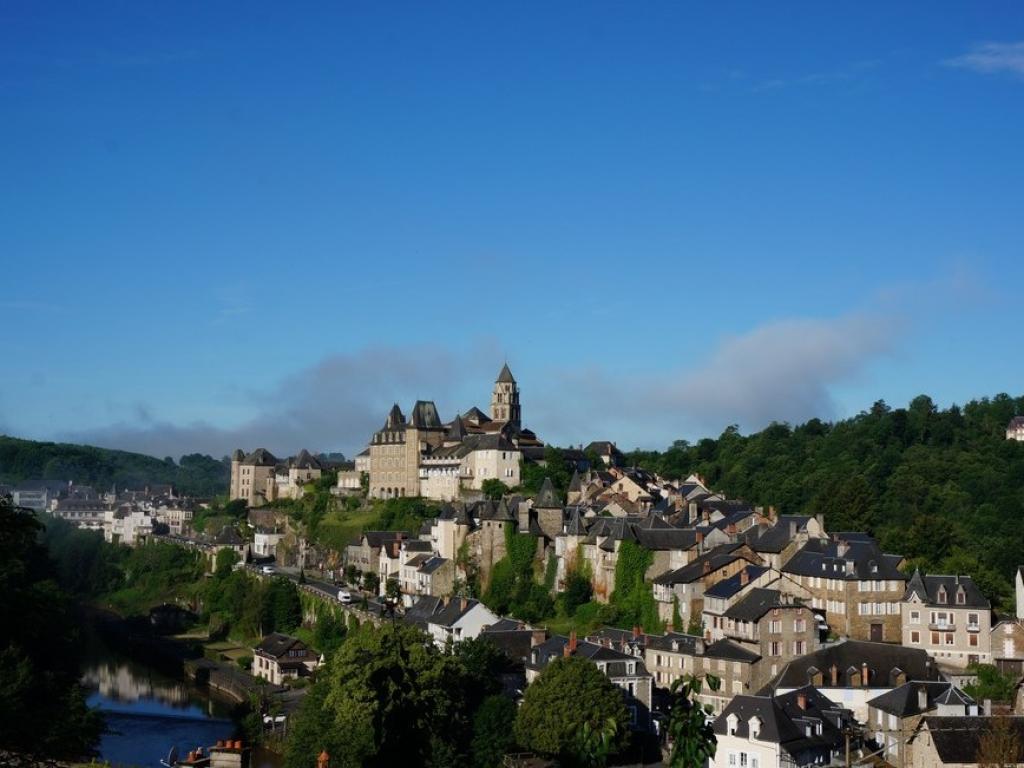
14;365;1024;768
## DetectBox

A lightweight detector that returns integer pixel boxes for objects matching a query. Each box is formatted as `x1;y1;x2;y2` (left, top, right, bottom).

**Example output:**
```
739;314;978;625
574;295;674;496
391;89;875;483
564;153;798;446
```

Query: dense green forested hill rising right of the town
628;394;1024;605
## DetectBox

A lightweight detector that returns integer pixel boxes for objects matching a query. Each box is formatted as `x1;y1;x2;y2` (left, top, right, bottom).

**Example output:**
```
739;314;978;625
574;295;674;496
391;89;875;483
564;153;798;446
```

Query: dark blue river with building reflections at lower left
82;636;280;768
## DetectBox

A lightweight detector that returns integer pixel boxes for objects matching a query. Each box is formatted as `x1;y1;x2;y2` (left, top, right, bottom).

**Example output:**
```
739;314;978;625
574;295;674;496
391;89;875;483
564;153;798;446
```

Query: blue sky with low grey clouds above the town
0;2;1024;456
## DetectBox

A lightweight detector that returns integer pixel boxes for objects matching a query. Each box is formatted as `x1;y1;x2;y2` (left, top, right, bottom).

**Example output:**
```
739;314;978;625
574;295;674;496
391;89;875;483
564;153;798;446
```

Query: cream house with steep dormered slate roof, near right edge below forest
902;570;992;670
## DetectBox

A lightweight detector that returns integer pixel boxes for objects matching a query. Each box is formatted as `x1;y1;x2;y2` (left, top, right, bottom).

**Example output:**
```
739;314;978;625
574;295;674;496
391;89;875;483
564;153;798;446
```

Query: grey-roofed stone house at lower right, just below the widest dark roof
865;681;978;768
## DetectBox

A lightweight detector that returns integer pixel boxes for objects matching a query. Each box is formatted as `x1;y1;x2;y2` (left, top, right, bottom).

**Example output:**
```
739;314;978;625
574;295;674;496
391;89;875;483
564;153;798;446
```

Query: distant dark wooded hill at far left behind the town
0;435;230;497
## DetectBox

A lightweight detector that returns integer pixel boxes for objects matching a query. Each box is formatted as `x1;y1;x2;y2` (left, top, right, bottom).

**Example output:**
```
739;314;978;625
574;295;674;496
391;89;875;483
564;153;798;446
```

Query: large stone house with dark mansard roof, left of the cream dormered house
781;534;906;643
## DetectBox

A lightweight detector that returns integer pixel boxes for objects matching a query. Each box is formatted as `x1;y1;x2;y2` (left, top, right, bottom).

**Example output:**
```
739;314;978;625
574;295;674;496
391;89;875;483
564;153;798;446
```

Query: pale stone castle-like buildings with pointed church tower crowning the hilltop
369;365;543;501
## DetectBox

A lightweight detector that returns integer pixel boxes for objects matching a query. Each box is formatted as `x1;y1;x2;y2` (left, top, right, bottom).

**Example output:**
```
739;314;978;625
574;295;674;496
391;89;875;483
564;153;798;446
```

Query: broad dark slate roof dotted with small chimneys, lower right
771;640;942;688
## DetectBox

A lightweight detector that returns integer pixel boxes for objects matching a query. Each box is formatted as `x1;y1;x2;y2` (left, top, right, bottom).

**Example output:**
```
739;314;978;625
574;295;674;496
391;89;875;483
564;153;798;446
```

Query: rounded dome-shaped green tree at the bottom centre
515;656;629;764
